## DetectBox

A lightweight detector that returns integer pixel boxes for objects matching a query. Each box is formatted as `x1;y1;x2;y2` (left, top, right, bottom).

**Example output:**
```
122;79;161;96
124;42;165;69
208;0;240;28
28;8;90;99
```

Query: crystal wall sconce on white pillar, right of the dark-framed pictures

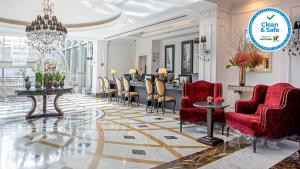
194;36;210;62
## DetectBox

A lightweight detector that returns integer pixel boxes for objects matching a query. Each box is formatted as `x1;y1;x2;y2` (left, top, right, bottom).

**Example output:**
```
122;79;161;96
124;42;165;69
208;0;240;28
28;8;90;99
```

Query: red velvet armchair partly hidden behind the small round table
179;81;225;133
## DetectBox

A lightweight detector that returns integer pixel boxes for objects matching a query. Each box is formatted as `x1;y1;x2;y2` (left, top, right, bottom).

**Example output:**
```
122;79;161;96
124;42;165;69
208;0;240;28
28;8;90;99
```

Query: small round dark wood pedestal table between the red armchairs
194;101;229;146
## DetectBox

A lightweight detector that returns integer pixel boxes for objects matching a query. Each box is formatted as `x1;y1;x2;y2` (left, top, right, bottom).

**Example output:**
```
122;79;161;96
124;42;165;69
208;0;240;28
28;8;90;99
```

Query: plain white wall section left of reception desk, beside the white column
106;39;136;77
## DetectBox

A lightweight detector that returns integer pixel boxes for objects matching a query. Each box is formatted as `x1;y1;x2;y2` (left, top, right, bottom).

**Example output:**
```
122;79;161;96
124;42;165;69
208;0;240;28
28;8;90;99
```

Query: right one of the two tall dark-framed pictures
181;40;194;74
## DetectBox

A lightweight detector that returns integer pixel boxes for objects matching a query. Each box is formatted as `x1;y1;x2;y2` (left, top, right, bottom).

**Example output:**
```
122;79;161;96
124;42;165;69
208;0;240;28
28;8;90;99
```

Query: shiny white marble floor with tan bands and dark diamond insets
0;95;300;169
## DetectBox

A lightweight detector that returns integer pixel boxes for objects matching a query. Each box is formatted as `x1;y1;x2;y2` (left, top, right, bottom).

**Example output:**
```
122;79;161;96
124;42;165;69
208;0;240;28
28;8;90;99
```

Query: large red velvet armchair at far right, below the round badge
226;83;300;152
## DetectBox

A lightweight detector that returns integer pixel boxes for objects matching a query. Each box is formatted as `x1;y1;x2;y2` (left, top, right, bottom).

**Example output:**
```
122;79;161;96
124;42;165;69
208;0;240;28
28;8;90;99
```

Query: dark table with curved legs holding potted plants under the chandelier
15;88;73;119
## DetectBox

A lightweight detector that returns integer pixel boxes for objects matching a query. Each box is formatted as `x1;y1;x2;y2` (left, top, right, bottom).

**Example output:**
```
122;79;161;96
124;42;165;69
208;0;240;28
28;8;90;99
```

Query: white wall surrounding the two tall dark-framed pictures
160;34;199;74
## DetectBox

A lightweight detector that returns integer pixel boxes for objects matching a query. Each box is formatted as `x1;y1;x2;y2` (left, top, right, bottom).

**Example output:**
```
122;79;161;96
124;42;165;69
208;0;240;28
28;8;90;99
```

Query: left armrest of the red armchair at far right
235;100;259;114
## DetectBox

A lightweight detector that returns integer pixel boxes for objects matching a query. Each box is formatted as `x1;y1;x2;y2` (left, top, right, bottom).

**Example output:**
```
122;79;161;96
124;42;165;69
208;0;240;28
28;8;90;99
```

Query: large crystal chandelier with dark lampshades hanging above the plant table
26;0;68;53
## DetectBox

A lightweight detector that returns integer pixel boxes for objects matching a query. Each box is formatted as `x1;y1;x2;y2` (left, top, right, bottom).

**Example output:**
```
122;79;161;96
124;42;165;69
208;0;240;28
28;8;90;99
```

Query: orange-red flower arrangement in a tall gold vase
226;35;264;86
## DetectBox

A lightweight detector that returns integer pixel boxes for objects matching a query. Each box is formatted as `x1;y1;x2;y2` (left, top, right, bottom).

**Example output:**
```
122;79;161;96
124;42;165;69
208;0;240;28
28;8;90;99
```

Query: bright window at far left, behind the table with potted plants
0;36;39;97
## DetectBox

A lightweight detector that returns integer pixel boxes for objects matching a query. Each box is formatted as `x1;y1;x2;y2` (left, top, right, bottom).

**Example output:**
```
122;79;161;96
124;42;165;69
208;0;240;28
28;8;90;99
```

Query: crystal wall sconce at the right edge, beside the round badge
283;21;300;56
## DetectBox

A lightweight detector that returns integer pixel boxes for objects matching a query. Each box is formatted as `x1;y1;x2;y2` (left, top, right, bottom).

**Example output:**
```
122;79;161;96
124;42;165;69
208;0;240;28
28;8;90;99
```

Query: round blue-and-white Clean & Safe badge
248;8;292;51
